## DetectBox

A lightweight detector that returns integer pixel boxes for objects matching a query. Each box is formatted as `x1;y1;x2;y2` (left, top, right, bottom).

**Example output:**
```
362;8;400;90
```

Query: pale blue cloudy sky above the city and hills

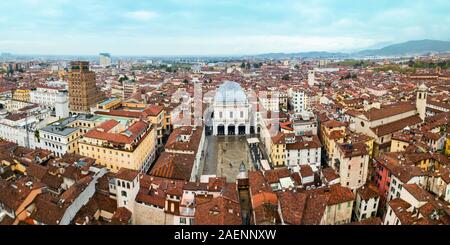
0;0;450;55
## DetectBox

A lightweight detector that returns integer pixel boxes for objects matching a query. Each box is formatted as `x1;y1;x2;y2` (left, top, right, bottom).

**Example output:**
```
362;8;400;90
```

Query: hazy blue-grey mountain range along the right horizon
253;40;450;59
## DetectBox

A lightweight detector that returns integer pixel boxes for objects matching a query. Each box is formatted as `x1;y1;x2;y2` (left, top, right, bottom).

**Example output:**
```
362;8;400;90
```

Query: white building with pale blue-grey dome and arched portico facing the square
213;81;255;135
